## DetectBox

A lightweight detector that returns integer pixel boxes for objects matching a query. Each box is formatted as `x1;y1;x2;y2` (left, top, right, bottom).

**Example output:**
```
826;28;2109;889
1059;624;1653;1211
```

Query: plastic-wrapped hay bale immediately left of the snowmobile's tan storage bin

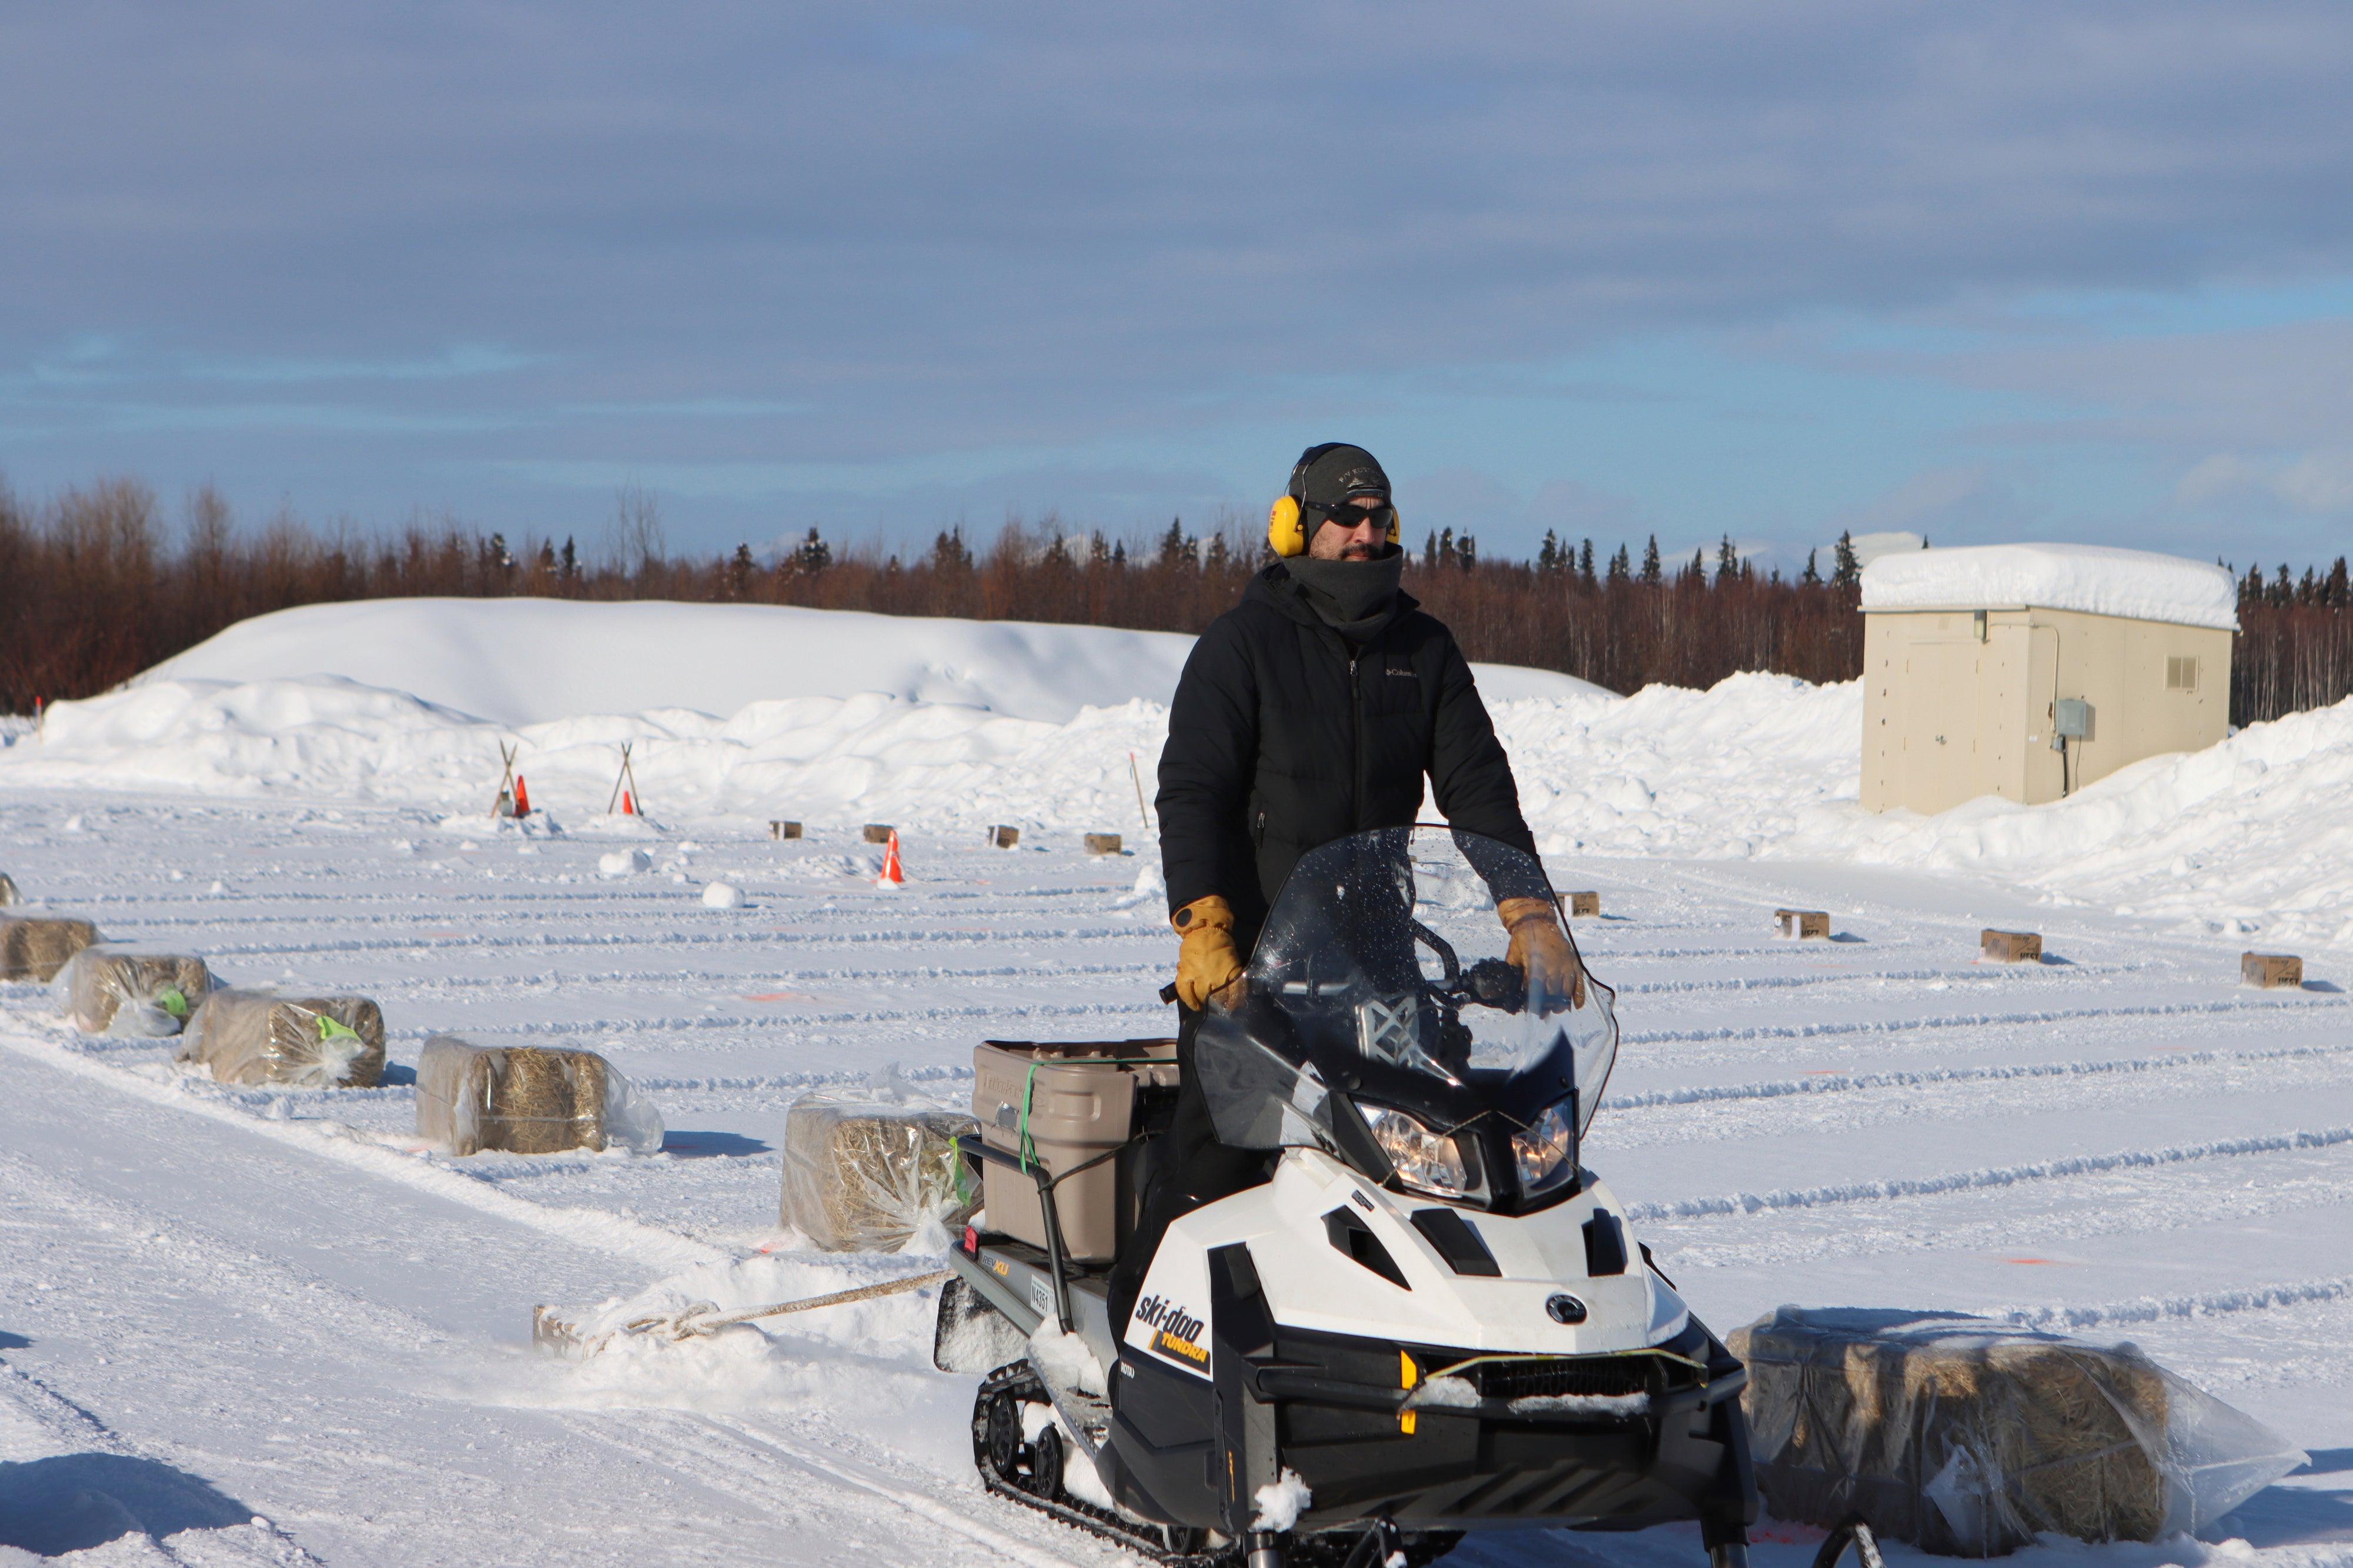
779;1090;981;1253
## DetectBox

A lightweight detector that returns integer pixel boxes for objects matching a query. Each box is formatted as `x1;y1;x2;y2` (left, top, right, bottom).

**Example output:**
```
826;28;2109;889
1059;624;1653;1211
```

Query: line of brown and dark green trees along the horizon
0;481;2353;723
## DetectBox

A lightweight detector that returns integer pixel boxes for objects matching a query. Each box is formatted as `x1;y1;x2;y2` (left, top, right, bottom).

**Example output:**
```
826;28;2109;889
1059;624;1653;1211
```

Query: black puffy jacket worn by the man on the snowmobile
1158;563;1537;953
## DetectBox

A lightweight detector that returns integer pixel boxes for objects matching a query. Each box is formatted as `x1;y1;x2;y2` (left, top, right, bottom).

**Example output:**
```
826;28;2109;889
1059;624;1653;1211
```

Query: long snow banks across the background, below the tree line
0;593;2353;946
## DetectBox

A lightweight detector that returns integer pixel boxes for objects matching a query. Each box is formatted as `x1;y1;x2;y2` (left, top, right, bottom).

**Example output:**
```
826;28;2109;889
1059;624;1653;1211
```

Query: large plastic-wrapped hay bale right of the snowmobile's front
1729;1307;2304;1556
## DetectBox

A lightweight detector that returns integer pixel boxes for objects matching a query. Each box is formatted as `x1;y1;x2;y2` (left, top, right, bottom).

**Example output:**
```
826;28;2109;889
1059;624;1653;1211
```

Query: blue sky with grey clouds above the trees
0;0;2353;563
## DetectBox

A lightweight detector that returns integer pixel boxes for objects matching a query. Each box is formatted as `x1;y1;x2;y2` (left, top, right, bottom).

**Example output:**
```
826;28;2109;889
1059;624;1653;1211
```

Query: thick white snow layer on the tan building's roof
1864;544;2238;631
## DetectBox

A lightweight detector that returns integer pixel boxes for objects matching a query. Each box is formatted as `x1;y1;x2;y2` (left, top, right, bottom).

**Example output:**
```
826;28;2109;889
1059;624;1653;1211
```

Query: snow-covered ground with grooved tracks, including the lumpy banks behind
0;593;2353;1568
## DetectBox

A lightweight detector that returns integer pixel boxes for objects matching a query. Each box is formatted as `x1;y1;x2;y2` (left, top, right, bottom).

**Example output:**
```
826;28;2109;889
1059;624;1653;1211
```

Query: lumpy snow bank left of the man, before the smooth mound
0;678;1167;838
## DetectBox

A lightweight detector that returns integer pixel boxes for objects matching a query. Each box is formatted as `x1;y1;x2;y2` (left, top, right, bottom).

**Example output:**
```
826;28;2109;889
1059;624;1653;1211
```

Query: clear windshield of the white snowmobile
1195;826;1617;1199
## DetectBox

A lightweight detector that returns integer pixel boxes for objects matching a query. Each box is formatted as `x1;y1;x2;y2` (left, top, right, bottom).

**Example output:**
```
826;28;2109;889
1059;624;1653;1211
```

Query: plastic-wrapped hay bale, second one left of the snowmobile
416;1033;661;1153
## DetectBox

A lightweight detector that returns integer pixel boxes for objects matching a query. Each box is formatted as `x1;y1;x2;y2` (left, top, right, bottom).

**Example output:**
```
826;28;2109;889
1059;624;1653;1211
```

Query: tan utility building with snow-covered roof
1864;544;2238;815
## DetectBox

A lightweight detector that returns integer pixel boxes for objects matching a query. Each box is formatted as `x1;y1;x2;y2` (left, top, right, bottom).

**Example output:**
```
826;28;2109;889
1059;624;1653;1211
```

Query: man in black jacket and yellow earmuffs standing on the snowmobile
1111;443;1584;1321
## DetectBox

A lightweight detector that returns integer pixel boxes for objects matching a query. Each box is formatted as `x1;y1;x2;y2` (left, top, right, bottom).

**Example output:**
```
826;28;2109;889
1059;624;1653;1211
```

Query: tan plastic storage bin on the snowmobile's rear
972;1040;1176;1265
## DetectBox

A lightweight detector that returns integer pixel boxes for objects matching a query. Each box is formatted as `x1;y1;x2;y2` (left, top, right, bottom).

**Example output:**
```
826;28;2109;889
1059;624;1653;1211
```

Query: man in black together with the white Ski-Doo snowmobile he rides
934;445;1755;1568
